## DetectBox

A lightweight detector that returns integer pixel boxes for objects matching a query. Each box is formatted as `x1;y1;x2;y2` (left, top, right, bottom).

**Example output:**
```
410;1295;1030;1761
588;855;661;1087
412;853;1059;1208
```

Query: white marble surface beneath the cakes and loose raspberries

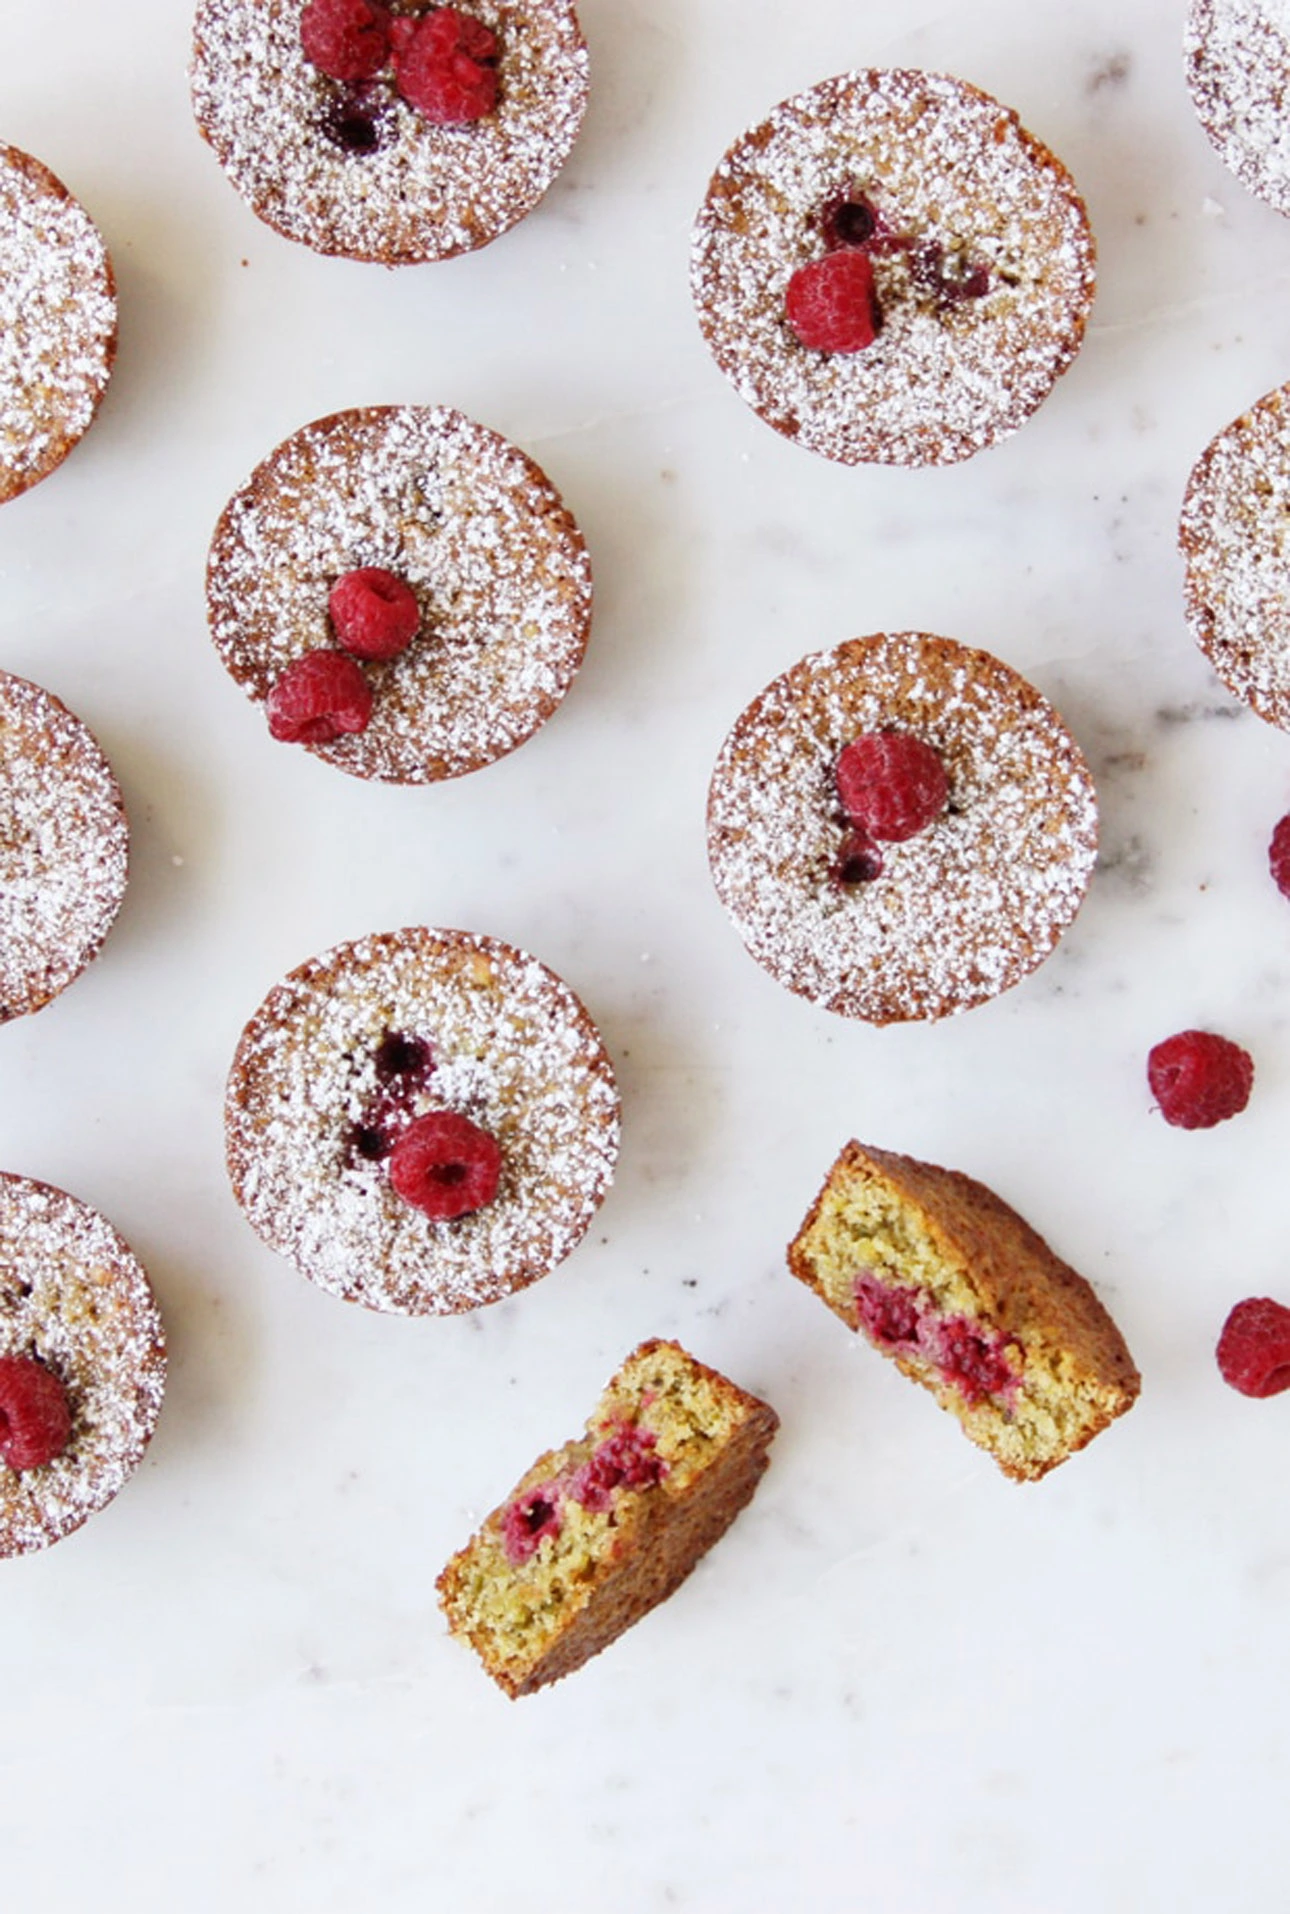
0;0;1290;1914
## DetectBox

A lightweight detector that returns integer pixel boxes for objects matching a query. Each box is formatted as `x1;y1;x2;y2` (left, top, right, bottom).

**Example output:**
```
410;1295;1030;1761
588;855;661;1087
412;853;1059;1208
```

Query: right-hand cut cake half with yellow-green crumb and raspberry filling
789;1143;1141;1481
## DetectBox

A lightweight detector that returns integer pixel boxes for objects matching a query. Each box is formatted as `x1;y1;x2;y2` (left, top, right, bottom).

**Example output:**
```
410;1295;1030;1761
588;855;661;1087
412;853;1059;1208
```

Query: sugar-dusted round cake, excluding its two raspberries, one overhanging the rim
207;406;591;785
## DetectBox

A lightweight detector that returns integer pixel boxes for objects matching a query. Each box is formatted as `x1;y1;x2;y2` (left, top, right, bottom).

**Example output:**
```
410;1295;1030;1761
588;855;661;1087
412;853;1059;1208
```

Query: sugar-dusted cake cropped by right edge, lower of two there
1179;385;1290;729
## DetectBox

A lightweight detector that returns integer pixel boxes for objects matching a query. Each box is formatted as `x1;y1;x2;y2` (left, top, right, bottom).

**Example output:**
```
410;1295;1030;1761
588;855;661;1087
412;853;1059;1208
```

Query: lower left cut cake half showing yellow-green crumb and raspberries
438;1342;779;1696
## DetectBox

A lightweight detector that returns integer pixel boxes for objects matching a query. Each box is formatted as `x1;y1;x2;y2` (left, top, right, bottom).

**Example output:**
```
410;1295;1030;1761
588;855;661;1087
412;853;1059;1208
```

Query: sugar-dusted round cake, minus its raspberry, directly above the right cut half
708;632;1097;1024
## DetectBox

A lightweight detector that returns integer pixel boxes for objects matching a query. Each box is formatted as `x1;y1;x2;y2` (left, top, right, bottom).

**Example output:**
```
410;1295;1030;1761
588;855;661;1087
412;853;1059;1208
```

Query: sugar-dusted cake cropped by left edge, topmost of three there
0;144;117;505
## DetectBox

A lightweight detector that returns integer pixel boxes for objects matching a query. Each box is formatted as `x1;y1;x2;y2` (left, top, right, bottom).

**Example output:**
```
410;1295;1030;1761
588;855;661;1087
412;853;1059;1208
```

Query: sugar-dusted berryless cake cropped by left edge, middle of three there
0;672;130;1024
